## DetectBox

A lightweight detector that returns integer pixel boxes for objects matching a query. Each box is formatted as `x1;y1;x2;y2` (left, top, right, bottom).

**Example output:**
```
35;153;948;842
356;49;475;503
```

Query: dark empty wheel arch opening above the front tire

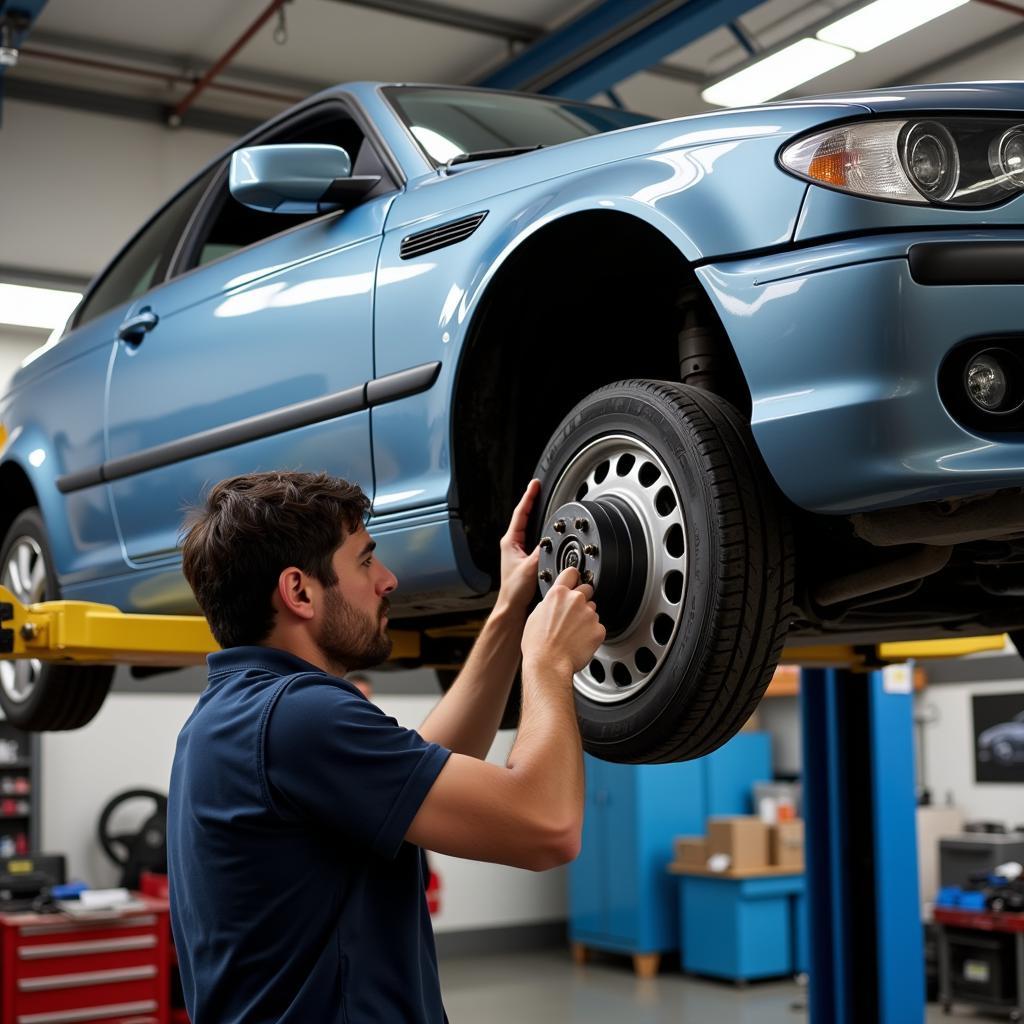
451;205;751;573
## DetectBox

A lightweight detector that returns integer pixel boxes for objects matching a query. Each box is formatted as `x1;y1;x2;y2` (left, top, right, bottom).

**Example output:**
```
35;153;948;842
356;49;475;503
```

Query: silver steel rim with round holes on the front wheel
545;434;689;705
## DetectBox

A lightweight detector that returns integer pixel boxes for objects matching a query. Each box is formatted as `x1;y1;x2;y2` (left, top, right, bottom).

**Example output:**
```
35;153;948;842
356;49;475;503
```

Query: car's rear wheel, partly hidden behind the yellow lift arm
0;508;114;732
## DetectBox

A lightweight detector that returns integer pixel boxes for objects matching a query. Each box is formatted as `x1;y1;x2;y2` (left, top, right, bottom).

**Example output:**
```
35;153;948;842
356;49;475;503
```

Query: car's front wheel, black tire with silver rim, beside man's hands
535;380;794;764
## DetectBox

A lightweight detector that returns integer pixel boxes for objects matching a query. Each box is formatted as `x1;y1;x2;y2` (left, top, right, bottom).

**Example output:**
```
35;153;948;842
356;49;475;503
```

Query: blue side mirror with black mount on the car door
227;143;380;213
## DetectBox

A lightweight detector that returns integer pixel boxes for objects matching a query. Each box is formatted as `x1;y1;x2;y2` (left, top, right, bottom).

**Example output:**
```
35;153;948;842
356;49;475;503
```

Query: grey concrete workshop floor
440;949;1007;1024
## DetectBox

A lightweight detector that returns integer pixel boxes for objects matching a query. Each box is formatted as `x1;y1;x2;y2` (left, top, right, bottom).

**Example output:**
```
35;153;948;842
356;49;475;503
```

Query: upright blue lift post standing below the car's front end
800;666;925;1024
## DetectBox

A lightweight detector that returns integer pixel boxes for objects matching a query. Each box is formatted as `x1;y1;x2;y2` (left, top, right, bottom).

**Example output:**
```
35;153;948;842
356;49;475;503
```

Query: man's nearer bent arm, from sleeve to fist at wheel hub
406;569;604;870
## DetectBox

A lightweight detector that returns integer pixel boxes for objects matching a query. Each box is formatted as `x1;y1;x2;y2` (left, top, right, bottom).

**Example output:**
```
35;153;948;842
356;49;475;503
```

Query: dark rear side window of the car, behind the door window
76;170;216;326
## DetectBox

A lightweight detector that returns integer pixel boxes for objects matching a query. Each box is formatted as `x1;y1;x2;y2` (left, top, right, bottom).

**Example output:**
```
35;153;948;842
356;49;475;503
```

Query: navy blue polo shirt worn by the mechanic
167;647;450;1024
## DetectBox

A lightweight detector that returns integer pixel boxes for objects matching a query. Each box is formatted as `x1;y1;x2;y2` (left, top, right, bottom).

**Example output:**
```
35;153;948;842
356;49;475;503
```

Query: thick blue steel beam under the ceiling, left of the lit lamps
476;0;762;99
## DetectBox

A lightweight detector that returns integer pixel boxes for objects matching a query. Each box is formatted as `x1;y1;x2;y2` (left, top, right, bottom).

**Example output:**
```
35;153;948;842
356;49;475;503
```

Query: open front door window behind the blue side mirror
182;108;394;269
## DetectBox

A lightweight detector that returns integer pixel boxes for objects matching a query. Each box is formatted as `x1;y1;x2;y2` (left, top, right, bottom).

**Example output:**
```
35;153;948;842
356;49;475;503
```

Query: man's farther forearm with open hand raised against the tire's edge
419;480;541;760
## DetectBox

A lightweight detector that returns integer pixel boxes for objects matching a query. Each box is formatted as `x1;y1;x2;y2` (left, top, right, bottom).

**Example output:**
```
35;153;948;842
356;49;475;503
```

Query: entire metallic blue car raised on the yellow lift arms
0;83;1024;762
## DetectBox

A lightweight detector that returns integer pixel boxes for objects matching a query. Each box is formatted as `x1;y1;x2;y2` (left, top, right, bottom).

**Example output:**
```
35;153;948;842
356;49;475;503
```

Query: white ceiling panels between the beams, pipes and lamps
8;0;1024;125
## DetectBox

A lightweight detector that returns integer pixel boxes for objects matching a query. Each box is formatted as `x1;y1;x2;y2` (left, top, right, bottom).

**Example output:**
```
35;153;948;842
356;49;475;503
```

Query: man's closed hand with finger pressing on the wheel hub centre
522;568;604;675
